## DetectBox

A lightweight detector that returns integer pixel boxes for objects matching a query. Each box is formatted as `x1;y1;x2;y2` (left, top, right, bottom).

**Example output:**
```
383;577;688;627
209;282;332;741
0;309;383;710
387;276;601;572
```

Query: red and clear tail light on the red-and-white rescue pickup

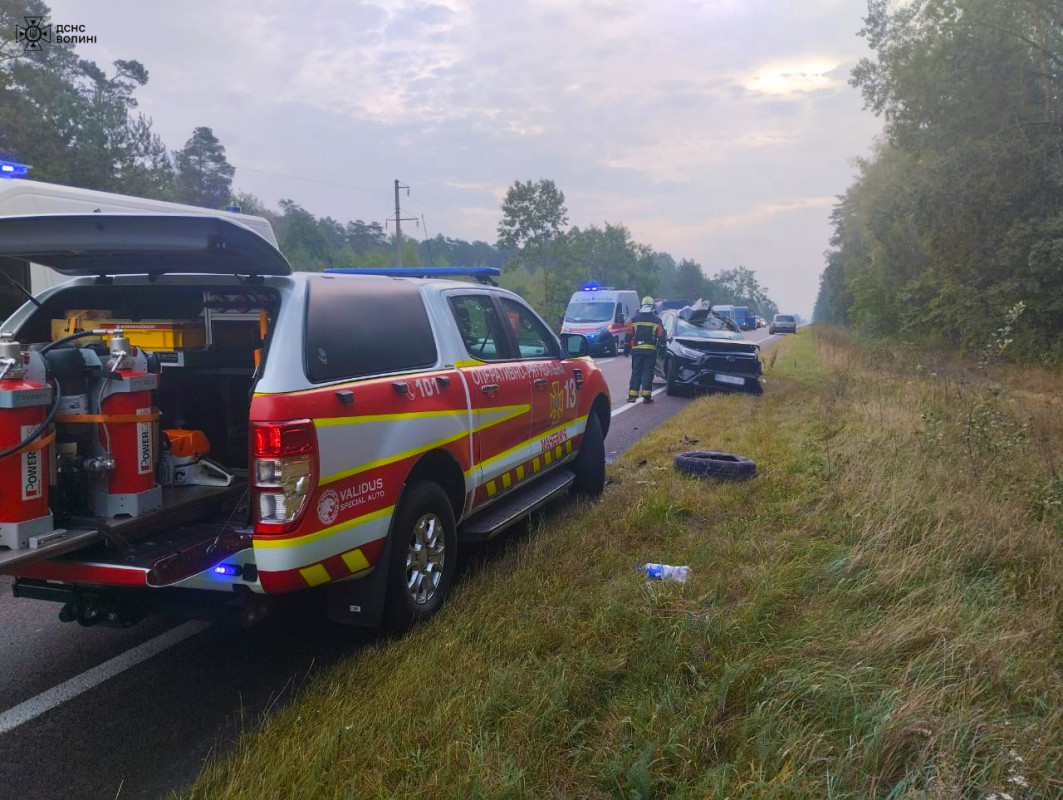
251;420;318;534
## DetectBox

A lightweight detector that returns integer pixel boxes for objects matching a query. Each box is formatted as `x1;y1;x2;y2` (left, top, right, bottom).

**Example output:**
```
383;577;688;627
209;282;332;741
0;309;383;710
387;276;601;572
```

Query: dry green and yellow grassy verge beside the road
178;330;1063;800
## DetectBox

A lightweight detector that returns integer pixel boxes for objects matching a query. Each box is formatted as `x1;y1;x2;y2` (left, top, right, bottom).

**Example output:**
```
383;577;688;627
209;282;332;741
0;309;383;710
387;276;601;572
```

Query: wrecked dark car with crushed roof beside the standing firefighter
656;301;763;395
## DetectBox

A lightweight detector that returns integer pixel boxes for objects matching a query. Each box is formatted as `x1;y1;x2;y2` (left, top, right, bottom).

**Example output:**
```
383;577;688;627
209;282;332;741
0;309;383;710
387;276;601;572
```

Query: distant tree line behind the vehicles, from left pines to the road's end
0;0;777;320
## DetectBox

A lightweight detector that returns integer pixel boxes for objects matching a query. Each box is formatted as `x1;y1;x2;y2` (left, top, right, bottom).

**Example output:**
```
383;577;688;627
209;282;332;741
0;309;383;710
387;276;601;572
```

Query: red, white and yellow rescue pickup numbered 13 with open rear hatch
0;215;610;628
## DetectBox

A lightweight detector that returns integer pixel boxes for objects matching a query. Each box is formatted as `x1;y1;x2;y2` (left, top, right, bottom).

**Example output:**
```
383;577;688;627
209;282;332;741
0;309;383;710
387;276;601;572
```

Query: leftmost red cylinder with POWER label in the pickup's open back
0;334;55;549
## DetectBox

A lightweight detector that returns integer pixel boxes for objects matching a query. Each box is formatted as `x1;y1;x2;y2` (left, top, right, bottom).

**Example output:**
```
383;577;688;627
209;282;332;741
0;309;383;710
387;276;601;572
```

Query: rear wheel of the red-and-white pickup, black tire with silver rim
384;481;457;631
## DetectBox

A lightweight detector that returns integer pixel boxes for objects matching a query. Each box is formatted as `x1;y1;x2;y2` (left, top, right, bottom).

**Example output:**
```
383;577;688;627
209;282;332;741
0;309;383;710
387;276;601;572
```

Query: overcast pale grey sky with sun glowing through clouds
50;0;880;316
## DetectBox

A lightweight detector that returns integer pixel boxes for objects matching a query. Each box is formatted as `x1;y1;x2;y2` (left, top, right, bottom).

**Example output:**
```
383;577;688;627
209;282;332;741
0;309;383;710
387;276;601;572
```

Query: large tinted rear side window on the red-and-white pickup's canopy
306;276;436;382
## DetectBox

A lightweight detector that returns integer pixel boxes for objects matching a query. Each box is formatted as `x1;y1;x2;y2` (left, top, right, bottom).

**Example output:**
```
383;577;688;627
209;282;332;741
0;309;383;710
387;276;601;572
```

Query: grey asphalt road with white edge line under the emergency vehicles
0;330;778;800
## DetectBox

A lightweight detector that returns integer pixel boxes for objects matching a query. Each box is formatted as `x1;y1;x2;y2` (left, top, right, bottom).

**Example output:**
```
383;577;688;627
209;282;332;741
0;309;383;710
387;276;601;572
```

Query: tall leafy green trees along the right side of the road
815;0;1063;361
